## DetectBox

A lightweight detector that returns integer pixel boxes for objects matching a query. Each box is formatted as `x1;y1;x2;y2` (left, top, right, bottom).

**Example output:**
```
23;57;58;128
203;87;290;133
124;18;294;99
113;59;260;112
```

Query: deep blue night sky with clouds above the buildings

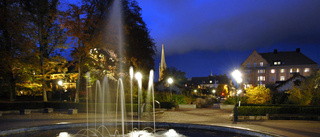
61;0;320;80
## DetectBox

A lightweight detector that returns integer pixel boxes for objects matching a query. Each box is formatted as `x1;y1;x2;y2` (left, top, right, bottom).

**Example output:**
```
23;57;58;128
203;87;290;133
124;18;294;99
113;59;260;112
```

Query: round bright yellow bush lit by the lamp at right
246;86;271;104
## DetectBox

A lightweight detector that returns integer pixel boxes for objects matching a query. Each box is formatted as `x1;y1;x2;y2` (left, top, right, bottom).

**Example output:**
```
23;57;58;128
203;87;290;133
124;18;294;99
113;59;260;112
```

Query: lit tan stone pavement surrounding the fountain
0;106;320;137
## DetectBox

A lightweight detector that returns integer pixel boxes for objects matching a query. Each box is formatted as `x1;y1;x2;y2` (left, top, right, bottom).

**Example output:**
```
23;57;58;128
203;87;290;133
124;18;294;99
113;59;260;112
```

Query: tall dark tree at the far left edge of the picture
0;0;36;101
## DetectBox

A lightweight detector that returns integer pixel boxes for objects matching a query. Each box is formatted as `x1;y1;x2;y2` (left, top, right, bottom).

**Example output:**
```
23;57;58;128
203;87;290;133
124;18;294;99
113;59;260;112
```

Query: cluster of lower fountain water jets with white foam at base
72;67;188;137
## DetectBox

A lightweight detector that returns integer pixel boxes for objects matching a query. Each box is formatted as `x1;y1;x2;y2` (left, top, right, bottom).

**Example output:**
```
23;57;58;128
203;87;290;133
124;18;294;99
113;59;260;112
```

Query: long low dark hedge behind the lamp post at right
238;106;320;116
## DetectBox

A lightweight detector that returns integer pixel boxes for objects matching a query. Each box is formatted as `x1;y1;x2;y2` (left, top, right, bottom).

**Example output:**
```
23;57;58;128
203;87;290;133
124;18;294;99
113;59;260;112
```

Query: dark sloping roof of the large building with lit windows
259;51;317;66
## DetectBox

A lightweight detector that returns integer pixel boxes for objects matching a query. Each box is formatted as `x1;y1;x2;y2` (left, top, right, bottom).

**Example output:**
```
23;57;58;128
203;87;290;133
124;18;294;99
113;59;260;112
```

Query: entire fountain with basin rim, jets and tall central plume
0;0;278;137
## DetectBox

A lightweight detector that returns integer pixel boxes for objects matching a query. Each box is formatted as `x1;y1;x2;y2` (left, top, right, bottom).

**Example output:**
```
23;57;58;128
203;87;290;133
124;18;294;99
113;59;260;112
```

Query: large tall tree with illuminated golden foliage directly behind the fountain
61;0;155;100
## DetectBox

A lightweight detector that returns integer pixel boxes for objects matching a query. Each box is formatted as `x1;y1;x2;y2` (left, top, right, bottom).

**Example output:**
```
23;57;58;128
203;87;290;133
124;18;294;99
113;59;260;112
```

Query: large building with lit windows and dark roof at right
240;48;318;88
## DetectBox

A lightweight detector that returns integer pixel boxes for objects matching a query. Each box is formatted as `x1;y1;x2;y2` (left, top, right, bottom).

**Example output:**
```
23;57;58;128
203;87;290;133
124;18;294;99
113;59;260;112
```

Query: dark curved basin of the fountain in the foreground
0;122;279;137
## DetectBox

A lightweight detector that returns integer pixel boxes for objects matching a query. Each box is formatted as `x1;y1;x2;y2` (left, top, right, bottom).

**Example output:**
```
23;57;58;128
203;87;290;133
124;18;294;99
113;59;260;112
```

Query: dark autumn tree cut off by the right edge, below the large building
288;71;320;105
